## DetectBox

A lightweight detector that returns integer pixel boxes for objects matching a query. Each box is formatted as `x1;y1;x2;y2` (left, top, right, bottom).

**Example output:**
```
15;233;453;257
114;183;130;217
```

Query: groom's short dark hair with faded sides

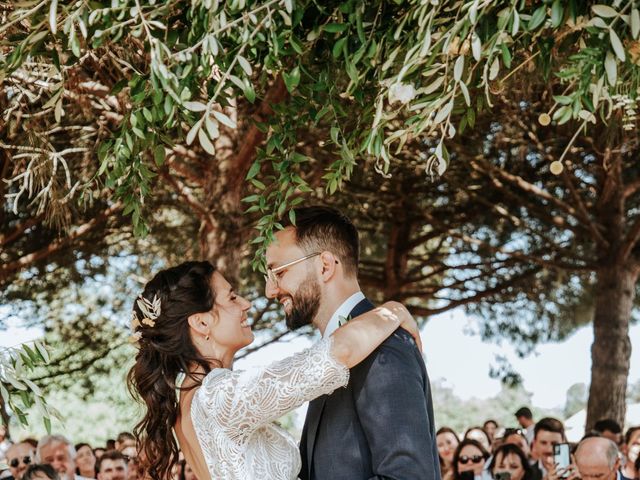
280;205;360;276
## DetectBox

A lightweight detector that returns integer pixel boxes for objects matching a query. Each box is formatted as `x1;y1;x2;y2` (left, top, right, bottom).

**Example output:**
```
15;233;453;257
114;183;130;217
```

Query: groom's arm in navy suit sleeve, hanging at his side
351;332;440;480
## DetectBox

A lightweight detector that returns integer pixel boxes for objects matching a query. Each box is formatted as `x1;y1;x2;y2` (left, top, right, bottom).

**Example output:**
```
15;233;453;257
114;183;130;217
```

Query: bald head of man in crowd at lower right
575;437;620;480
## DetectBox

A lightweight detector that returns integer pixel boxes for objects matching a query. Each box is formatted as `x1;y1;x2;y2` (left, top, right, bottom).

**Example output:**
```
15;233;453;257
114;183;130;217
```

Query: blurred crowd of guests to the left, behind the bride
0;426;198;480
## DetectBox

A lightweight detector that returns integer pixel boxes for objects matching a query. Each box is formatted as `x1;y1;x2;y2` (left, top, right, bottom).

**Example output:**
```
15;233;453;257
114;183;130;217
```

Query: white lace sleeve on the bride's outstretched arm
196;337;349;437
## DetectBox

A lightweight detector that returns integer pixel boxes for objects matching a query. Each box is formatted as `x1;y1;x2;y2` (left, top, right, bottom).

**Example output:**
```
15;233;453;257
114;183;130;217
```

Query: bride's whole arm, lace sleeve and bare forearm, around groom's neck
192;302;417;438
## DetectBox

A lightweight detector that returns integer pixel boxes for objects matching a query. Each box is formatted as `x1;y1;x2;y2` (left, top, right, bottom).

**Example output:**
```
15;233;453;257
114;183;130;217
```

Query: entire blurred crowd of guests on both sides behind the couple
0;407;640;480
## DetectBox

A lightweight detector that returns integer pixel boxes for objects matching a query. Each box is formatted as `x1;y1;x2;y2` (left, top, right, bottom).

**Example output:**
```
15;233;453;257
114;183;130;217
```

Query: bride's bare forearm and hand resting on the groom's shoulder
331;302;422;368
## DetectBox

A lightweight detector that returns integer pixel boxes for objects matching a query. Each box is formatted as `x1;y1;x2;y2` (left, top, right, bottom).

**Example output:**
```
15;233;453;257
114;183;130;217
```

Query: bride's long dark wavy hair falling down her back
127;262;215;478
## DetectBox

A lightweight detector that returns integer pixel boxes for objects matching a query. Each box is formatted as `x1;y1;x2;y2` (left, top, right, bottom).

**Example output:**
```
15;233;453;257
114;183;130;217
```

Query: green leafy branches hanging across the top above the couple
0;0;640;266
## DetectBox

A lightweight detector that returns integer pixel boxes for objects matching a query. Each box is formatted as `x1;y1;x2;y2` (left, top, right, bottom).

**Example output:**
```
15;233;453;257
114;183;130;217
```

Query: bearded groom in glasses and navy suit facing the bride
266;207;440;480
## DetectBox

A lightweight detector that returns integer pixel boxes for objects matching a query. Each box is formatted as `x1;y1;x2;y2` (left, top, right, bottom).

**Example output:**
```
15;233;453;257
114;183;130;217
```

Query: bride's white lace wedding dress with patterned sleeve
191;338;349;480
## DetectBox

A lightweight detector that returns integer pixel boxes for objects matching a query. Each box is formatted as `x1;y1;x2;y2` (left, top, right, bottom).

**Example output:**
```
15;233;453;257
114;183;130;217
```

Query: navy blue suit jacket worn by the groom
300;299;440;480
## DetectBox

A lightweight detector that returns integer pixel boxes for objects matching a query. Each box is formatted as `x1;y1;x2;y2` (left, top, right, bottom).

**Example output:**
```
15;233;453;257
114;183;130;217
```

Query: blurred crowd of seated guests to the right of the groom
436;407;640;480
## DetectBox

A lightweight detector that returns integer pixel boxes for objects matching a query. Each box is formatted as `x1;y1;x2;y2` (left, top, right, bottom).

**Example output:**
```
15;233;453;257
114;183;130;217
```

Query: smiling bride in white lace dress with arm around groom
128;262;420;480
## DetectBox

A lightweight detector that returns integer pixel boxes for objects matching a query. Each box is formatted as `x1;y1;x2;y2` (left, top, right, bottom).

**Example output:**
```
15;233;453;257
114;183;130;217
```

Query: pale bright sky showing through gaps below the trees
5;307;640;408
